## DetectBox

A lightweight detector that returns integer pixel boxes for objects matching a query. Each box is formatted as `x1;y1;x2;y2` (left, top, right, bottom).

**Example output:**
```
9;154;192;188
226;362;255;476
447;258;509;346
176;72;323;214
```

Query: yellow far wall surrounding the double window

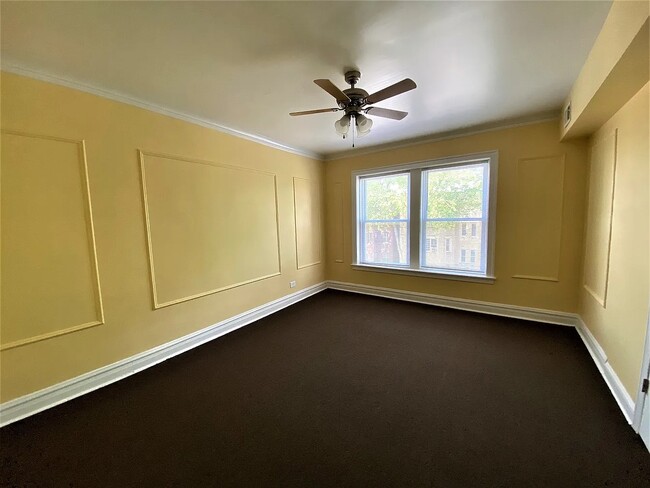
325;121;587;312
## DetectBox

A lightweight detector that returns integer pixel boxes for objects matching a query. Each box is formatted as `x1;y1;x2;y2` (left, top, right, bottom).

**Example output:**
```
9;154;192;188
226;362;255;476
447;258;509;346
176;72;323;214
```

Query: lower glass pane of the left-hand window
361;222;408;265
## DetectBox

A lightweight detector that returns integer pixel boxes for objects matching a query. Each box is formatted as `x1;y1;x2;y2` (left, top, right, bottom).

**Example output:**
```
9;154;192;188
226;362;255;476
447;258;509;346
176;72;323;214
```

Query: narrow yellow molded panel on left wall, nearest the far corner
293;178;321;269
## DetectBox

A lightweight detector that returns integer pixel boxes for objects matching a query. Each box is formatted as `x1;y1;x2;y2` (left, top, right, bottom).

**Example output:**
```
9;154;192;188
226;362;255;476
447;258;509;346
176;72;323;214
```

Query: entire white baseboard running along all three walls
0;281;639;431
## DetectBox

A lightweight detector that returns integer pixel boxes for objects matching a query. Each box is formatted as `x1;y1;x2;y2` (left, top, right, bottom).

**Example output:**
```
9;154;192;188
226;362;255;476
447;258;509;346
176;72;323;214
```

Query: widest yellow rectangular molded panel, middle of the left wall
138;151;281;309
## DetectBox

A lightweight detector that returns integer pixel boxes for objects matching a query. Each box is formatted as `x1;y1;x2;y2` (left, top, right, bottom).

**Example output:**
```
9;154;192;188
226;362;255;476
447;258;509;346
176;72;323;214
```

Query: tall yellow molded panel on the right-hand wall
584;130;616;307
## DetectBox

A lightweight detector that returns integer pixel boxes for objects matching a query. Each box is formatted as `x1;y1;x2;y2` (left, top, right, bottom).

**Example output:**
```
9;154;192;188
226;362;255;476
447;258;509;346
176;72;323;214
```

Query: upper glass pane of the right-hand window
422;163;487;217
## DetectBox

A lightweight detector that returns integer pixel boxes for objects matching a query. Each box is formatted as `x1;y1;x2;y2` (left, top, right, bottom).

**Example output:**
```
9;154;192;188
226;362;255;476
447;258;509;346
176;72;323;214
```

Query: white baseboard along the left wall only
0;282;327;427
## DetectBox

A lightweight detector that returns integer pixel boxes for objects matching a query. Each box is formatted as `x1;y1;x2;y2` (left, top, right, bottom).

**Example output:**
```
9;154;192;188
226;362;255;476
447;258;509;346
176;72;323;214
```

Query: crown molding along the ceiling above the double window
323;113;560;161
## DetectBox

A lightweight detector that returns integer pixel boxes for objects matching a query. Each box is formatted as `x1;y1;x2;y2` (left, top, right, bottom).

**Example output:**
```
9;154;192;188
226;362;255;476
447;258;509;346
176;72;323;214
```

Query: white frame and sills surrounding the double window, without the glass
351;151;499;283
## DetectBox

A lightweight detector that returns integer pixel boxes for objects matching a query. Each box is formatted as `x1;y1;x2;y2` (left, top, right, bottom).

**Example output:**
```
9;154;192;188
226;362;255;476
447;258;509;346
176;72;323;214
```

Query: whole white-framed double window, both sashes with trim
352;152;497;281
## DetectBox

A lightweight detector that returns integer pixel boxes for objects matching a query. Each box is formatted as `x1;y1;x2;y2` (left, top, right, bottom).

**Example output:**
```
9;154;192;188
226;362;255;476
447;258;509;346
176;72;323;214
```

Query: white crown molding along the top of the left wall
0;63;323;161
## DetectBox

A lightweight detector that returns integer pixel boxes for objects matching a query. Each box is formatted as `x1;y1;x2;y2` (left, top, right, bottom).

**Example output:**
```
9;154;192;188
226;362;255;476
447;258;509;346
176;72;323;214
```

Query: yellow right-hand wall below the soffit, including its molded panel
580;84;650;399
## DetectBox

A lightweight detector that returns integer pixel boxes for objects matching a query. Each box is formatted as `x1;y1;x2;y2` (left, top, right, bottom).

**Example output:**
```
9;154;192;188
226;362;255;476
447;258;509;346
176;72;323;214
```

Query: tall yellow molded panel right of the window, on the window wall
513;156;564;281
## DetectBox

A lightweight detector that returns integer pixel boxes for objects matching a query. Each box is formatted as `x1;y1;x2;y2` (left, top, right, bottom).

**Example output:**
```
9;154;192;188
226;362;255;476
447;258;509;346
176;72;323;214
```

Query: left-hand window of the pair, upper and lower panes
358;173;410;266
